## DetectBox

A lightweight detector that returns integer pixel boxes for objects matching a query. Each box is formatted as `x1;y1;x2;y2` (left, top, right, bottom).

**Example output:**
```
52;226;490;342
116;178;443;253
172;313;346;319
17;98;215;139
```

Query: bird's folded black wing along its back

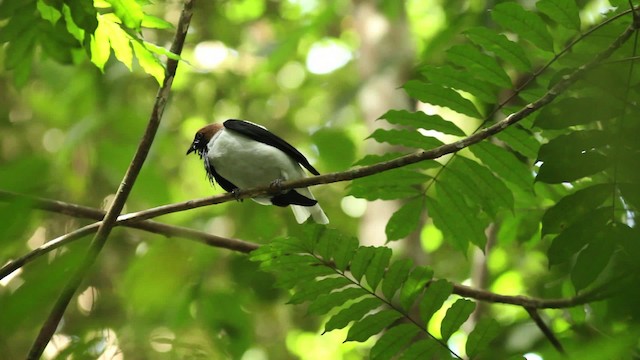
220;119;320;175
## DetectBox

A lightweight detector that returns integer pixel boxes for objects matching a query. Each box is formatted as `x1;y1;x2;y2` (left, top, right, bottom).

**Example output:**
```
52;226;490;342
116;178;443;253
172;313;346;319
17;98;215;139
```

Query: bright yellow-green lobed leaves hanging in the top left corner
0;0;175;87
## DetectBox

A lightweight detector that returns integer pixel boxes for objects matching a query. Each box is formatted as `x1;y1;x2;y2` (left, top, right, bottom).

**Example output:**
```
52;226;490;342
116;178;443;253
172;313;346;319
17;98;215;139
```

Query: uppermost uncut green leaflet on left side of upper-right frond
491;2;553;52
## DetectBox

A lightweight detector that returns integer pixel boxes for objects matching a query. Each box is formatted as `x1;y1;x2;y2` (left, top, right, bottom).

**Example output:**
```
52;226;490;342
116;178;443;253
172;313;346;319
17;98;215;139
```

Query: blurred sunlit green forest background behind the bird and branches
0;0;637;359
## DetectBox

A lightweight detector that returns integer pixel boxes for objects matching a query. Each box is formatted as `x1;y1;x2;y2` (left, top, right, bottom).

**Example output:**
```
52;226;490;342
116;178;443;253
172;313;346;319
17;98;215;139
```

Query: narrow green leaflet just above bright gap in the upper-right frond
404;80;482;119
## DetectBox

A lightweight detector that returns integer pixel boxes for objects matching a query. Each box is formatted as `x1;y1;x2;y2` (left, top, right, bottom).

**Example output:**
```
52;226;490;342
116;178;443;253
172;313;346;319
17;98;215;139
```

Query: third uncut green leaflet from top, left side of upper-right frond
447;44;512;89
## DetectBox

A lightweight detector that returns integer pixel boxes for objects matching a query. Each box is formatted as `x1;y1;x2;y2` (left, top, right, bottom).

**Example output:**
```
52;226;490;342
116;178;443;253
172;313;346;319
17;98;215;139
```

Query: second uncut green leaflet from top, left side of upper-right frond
464;27;531;71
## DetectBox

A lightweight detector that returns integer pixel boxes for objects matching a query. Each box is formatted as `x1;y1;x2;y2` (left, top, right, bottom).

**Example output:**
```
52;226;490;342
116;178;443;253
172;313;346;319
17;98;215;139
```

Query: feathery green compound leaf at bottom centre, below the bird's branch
251;225;488;359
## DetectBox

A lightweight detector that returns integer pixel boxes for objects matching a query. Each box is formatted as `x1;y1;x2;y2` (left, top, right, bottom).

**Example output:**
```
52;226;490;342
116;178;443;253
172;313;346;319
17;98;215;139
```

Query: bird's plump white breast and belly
207;129;304;189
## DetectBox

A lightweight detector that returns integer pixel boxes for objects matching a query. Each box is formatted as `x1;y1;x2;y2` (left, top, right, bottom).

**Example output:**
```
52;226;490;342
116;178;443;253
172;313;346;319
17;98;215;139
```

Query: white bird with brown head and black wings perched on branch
186;119;329;224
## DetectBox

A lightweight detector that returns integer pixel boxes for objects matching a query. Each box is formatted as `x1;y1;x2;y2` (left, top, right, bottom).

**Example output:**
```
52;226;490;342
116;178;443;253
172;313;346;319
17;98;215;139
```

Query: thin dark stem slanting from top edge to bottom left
27;0;193;359
